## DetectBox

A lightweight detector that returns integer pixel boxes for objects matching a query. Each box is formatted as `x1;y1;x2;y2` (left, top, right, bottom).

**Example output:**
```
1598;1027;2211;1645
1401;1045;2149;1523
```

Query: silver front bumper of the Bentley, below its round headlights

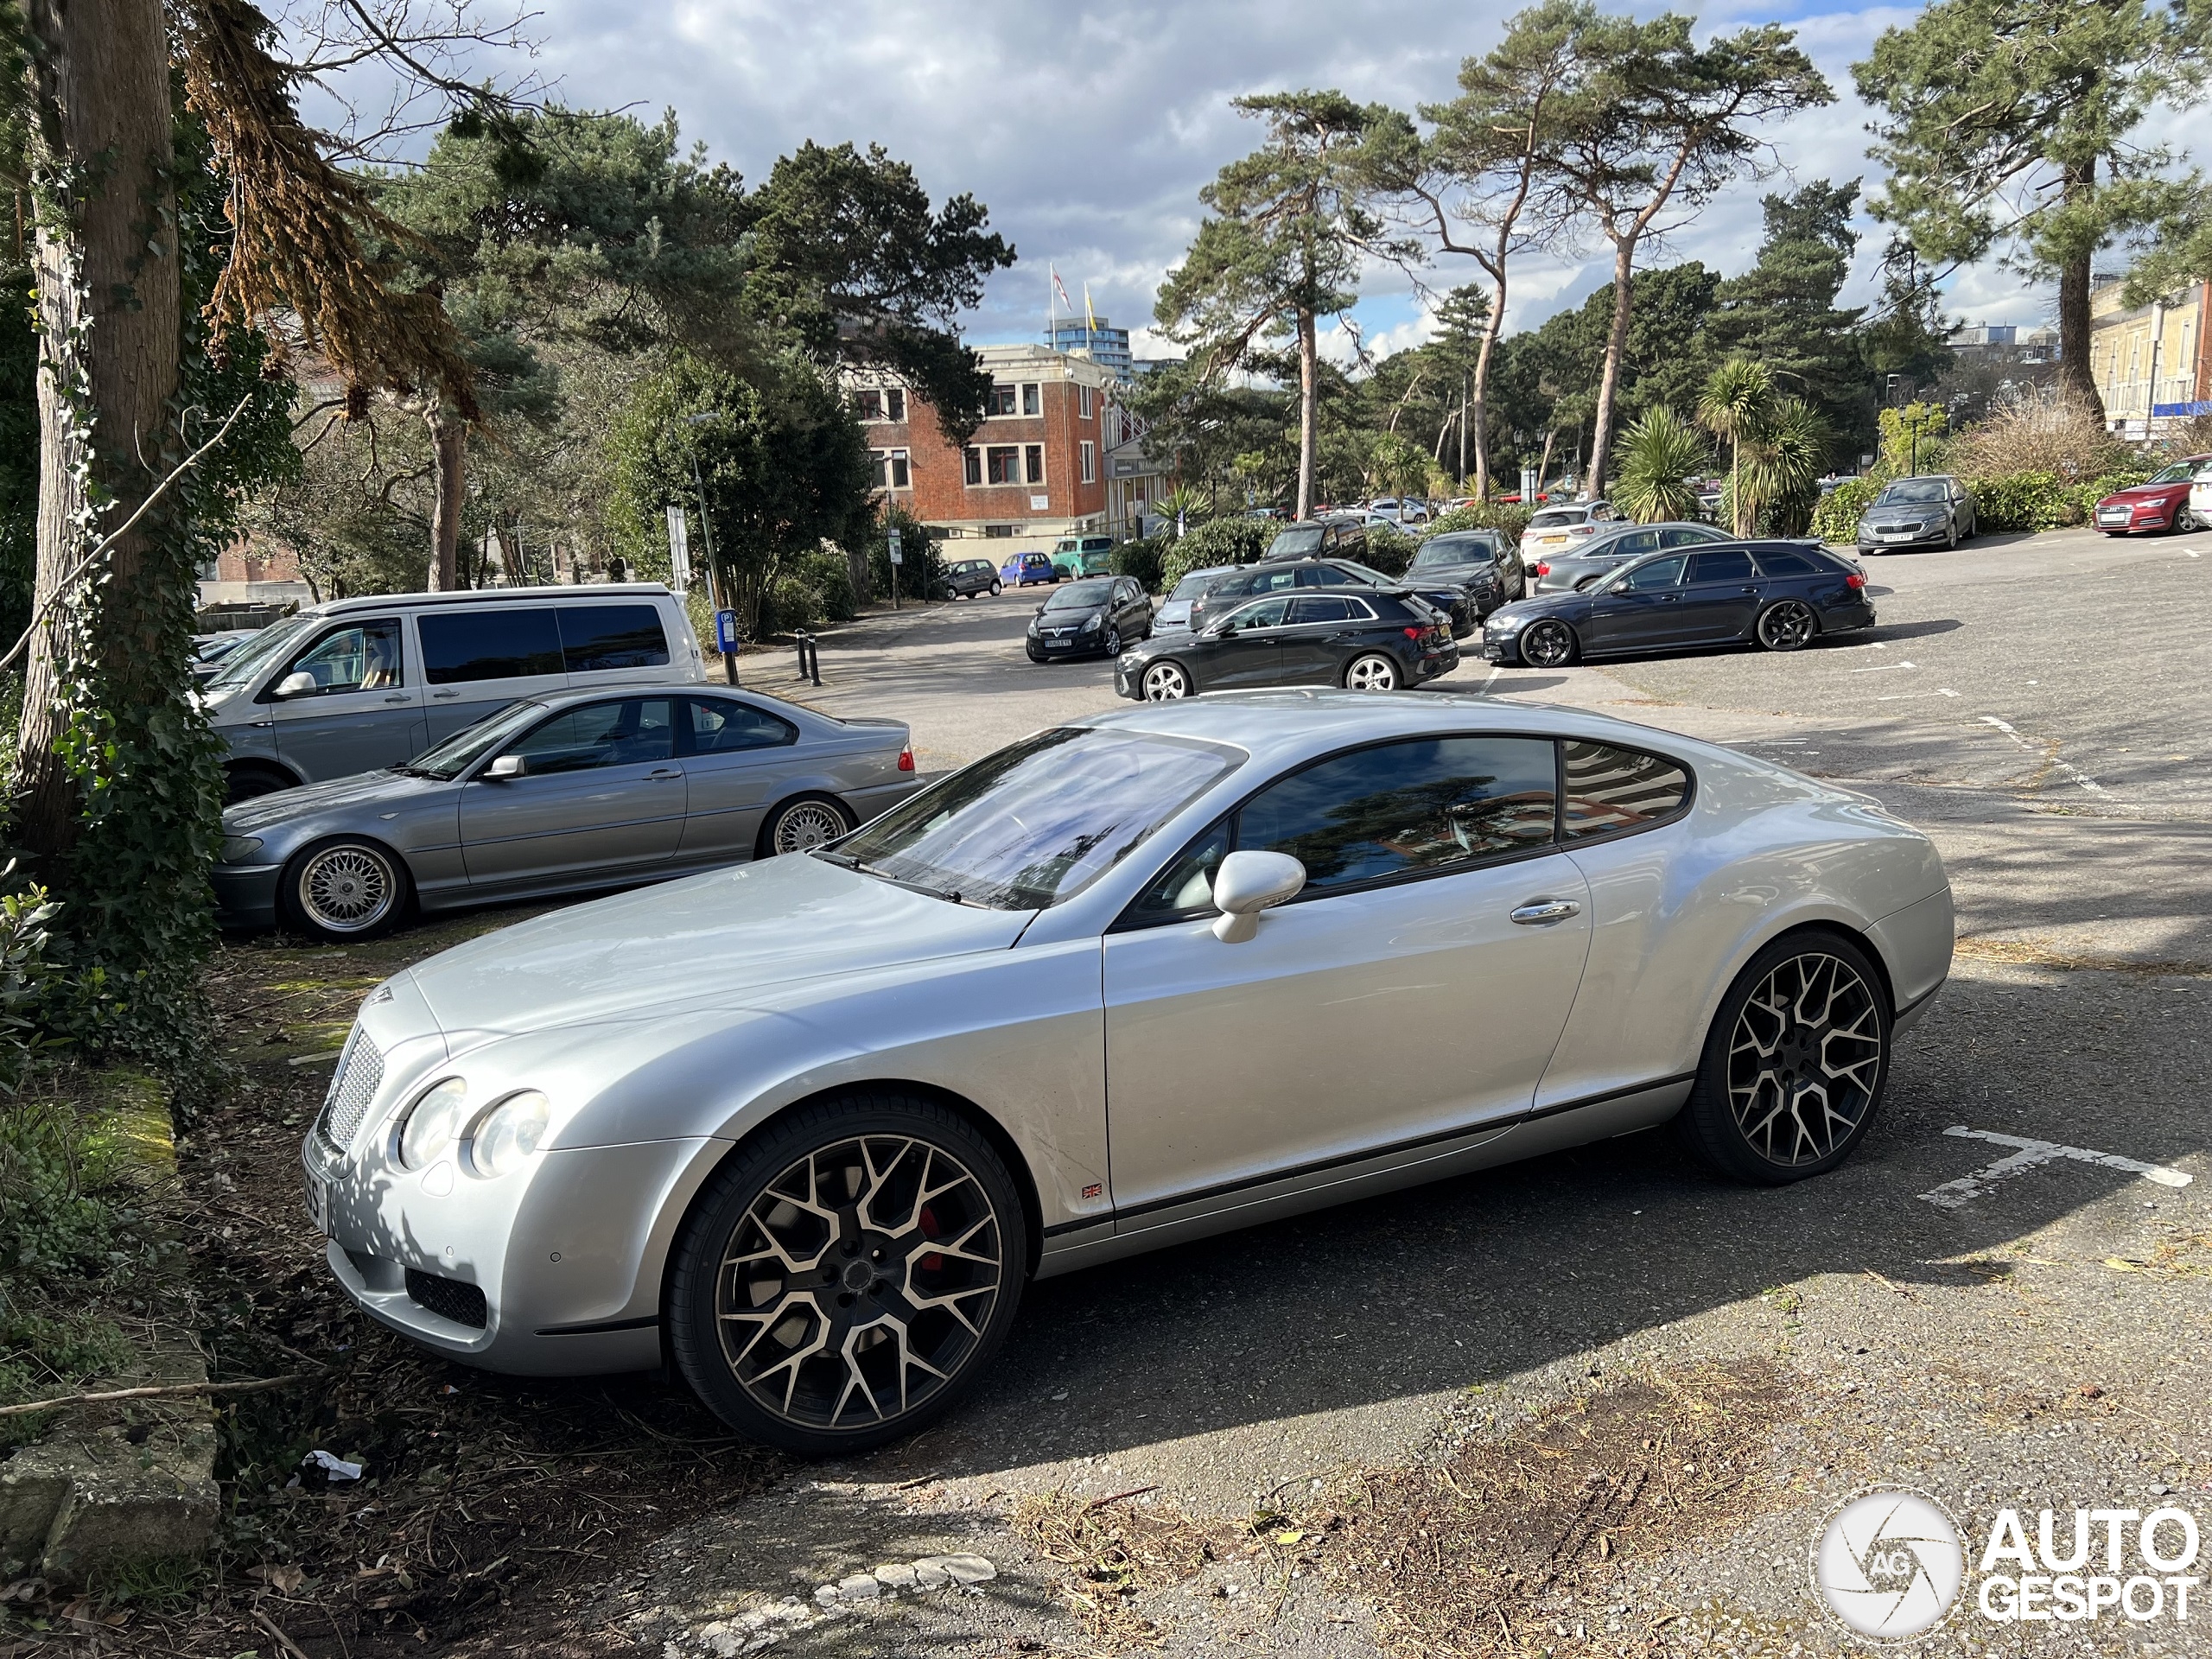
301;1133;721;1376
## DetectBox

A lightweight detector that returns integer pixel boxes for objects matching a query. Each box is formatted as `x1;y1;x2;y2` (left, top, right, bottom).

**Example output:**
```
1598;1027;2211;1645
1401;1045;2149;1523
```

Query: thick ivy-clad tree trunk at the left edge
16;0;181;861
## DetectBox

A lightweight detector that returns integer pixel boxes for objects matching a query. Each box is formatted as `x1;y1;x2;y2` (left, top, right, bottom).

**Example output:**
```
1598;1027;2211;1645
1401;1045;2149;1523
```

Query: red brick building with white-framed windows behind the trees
847;345;1117;544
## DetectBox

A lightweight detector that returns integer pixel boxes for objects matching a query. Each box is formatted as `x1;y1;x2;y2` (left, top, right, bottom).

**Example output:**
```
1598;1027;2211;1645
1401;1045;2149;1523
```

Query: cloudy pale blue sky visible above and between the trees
316;0;2194;369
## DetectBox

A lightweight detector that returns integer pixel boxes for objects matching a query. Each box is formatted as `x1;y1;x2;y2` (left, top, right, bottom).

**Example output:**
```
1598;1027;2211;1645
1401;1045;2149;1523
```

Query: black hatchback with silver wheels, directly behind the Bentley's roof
1115;588;1460;703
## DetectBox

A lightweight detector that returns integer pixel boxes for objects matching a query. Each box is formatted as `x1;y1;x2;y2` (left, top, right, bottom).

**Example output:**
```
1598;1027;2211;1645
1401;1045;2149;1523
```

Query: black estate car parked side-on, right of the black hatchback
1482;542;1873;668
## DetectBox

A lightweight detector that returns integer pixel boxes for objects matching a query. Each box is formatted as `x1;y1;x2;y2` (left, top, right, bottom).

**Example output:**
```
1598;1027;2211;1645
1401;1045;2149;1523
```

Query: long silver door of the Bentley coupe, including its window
1103;736;1591;1219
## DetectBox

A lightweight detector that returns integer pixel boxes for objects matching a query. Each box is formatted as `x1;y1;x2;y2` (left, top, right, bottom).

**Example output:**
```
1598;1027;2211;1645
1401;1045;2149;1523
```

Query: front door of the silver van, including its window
261;617;429;783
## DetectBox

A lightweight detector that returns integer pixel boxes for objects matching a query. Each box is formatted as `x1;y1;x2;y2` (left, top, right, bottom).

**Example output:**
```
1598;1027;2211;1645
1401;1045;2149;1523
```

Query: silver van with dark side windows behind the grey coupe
199;582;708;801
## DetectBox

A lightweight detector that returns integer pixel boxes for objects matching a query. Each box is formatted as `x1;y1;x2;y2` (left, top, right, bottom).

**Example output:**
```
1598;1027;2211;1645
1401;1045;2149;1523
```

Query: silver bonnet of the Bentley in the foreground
411;854;1035;1038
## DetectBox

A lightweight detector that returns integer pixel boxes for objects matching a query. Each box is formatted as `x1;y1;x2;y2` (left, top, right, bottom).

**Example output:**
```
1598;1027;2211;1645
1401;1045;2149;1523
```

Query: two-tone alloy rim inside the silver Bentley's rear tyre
1727;951;1885;1170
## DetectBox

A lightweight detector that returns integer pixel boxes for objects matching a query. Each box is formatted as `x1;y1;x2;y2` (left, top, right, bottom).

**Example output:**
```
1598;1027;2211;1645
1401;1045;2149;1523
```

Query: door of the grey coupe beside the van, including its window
460;696;686;887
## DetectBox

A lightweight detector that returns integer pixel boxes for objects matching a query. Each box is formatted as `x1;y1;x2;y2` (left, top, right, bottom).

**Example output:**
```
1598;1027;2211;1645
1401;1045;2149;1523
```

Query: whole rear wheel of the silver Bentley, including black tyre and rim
1675;931;1891;1185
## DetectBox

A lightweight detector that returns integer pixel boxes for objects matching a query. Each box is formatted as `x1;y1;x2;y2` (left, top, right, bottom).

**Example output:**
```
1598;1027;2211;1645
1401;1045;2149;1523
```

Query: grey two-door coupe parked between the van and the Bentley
213;683;918;940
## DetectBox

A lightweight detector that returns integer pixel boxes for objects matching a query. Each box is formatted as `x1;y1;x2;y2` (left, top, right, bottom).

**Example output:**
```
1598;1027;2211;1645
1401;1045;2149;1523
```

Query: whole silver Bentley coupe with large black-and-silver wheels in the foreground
305;692;1951;1453
